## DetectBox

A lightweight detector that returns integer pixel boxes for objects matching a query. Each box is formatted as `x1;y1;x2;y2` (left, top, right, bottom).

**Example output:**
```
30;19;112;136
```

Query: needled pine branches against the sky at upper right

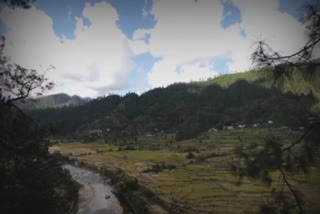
251;3;320;86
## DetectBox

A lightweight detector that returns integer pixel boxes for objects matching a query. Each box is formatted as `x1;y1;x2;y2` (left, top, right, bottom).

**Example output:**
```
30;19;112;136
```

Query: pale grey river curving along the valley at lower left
64;164;126;214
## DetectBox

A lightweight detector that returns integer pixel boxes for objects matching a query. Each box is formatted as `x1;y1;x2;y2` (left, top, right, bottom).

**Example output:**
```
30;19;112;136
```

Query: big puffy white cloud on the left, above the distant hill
0;2;134;97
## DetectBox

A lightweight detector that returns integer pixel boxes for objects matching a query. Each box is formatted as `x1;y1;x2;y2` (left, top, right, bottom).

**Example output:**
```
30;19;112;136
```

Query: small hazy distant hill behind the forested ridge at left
17;93;89;110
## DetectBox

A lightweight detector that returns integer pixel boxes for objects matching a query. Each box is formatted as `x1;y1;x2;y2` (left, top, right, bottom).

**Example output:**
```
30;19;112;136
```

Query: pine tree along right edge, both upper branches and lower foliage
231;5;320;214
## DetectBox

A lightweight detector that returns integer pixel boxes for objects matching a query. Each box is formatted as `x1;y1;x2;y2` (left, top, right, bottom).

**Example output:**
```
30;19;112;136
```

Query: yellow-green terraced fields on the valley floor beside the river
51;129;320;214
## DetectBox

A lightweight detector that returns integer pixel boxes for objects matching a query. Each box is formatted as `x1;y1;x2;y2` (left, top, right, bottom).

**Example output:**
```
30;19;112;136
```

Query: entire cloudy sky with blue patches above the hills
0;0;307;97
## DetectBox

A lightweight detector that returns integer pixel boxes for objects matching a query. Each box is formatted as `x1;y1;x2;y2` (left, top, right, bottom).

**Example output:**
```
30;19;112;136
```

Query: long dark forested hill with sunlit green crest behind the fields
30;72;320;140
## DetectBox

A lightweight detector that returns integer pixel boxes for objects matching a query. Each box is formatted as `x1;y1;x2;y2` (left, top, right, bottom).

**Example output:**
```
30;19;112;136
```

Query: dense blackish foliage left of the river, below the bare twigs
0;106;78;213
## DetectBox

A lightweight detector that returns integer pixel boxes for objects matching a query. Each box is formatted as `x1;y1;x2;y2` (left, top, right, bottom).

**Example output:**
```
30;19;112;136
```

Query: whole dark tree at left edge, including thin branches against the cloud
0;36;79;214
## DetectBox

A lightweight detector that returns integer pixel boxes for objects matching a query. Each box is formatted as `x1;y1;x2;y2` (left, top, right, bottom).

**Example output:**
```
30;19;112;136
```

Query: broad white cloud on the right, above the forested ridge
131;0;304;87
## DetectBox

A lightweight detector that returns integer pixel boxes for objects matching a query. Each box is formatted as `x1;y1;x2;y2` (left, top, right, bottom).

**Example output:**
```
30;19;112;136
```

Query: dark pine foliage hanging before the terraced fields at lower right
231;124;320;213
